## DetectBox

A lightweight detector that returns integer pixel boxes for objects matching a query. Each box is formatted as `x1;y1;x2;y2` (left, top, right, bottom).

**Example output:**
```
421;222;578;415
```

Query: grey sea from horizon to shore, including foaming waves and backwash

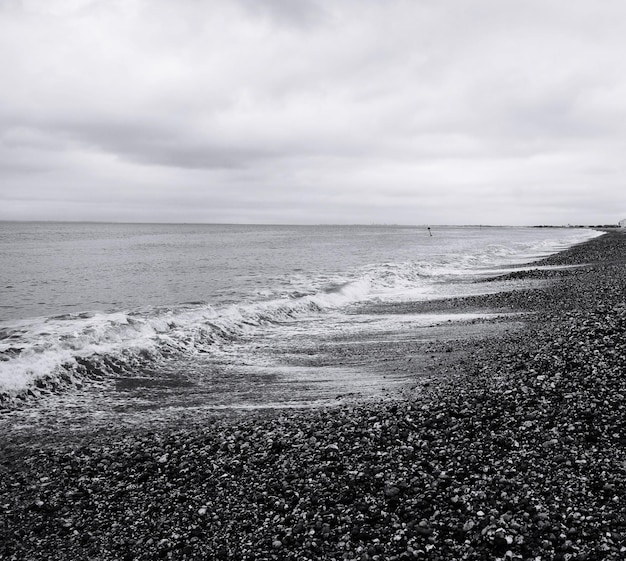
0;222;599;414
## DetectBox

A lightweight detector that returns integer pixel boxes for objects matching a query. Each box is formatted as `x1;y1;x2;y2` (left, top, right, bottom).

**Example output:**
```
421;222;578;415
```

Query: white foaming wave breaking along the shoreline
0;225;600;406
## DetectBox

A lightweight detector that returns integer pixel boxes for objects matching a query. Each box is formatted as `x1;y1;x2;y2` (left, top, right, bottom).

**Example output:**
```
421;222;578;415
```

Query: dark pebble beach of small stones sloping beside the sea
0;232;626;561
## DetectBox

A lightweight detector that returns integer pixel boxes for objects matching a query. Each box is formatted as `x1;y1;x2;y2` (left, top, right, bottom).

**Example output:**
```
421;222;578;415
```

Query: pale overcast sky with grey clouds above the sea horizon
0;0;626;225
